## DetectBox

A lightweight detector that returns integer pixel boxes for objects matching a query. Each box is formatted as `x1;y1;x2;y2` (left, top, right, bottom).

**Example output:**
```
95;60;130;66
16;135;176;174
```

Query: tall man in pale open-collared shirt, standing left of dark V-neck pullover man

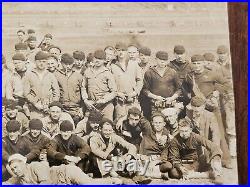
111;43;143;119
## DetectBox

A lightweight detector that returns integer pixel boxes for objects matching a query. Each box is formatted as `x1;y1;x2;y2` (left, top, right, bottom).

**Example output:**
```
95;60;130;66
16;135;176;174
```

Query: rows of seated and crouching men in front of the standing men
2;97;223;184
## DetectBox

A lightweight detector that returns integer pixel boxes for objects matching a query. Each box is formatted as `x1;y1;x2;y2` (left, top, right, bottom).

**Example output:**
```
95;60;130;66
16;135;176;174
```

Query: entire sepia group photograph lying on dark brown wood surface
2;2;239;185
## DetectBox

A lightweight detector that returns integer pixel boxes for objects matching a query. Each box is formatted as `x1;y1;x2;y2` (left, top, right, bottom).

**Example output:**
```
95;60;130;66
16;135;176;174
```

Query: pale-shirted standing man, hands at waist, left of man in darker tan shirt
24;51;60;119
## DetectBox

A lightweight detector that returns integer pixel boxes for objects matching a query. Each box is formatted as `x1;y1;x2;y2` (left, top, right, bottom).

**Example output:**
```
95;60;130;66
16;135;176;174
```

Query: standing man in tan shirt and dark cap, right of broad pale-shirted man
55;53;83;124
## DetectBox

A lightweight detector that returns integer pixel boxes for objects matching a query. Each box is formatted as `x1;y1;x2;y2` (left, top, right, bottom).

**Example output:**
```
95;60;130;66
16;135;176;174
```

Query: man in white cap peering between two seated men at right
162;108;179;140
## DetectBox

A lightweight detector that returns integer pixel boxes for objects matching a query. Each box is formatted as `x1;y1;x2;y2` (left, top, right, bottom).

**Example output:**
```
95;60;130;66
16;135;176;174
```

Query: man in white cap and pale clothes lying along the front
3;154;121;184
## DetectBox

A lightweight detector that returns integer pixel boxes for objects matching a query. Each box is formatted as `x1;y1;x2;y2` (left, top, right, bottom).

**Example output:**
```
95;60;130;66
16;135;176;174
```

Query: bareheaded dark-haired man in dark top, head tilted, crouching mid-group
116;107;152;150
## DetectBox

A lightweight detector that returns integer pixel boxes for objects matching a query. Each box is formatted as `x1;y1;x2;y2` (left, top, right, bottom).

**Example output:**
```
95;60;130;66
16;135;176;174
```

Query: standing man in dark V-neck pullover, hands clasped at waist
143;51;180;115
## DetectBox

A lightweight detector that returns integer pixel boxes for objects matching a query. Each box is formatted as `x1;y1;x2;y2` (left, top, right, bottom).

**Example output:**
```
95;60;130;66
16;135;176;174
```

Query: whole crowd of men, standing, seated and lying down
2;29;236;184
